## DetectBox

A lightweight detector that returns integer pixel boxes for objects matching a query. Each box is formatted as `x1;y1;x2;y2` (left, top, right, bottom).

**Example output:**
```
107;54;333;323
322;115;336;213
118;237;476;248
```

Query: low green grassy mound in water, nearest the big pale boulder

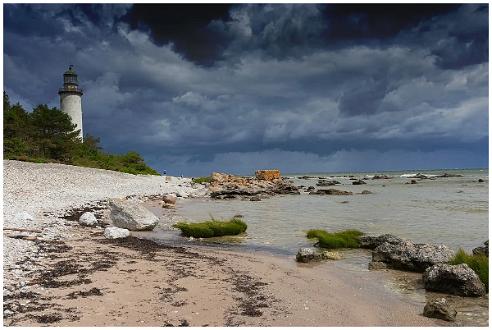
173;218;248;238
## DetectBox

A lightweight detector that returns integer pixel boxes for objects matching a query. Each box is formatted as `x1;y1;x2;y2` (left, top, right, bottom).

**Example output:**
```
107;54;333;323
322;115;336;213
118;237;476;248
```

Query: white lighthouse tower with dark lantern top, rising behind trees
58;65;84;140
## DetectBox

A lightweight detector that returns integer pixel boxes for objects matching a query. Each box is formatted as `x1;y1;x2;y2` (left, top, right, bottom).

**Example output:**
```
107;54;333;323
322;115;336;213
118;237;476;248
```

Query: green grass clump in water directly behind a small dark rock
307;229;363;249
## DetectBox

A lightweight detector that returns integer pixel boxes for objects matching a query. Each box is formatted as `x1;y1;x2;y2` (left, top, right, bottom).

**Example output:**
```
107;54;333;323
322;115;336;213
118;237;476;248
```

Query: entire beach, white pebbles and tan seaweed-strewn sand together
3;161;484;326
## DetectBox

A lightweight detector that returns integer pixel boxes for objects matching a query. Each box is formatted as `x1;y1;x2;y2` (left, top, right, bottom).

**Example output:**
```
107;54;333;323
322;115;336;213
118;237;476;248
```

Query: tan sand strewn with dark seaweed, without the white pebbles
4;222;445;326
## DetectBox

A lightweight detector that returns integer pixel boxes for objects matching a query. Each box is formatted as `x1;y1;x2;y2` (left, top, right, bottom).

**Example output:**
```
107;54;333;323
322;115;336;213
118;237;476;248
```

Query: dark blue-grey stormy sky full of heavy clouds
3;4;489;176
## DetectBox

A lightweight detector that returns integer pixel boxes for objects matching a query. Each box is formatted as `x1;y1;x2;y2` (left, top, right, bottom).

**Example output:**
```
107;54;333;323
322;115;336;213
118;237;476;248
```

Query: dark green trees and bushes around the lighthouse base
3;92;159;175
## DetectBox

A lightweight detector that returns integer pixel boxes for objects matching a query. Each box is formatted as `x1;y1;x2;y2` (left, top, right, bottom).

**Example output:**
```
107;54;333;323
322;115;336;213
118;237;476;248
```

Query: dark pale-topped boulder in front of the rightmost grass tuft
422;264;485;297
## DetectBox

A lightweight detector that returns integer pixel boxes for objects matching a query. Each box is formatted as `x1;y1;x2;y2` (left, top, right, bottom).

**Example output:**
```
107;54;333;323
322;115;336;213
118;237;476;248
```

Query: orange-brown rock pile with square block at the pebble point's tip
209;170;299;200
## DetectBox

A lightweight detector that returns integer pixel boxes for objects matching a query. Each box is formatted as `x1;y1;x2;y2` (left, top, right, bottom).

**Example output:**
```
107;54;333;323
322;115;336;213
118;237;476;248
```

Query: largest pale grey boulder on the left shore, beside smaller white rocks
109;199;159;230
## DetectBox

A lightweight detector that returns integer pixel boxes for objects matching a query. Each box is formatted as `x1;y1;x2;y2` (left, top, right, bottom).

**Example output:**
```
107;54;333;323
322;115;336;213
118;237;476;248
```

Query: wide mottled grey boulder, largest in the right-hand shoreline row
372;240;454;272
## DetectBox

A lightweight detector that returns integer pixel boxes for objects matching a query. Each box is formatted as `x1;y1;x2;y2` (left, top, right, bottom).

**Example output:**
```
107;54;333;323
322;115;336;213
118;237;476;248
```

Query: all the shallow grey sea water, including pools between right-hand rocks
138;170;488;326
